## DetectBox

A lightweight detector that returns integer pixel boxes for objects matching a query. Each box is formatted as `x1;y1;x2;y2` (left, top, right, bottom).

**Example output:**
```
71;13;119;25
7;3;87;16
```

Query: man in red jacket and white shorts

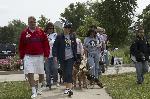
19;16;50;98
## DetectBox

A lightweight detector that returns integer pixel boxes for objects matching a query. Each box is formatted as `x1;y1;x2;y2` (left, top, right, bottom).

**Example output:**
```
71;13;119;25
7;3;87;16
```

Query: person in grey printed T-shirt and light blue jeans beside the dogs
84;29;101;78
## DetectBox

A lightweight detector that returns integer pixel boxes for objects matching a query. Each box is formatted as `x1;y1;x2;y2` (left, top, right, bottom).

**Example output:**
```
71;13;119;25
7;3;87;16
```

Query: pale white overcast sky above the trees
0;0;150;26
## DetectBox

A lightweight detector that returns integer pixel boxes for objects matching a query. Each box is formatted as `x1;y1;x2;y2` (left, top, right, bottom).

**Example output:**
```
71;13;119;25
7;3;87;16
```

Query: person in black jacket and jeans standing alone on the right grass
130;28;149;84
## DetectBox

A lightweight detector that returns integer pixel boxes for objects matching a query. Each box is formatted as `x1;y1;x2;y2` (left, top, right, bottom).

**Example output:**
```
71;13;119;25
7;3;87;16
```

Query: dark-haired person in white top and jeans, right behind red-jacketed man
44;22;59;89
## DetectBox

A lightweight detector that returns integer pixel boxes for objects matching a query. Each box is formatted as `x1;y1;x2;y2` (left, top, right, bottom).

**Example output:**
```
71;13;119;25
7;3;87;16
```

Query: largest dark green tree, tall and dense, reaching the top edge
90;0;137;46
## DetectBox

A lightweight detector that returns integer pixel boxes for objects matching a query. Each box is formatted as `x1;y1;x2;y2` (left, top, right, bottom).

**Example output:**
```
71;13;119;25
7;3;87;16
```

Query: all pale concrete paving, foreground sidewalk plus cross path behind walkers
0;67;135;99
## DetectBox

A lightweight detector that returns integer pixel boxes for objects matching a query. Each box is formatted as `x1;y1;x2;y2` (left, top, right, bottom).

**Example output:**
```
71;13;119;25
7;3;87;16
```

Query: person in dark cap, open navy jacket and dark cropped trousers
52;23;77;95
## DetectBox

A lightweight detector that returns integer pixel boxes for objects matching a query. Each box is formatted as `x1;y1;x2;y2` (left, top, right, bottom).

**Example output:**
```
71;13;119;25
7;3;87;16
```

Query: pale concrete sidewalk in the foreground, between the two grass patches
37;86;112;99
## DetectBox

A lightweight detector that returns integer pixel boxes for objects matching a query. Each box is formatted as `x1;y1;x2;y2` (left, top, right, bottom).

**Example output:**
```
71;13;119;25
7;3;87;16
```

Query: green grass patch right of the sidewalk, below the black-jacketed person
102;73;150;99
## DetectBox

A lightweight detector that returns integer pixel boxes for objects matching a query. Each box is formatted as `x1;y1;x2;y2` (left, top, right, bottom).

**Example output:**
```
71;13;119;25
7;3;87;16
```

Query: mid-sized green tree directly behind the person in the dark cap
61;2;87;31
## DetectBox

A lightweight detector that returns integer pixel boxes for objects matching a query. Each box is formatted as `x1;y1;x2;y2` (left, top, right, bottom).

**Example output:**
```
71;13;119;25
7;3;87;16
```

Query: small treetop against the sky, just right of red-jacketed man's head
37;15;50;29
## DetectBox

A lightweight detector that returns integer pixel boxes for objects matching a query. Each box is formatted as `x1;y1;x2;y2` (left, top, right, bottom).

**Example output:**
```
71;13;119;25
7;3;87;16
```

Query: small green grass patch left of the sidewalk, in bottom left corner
0;82;31;99
